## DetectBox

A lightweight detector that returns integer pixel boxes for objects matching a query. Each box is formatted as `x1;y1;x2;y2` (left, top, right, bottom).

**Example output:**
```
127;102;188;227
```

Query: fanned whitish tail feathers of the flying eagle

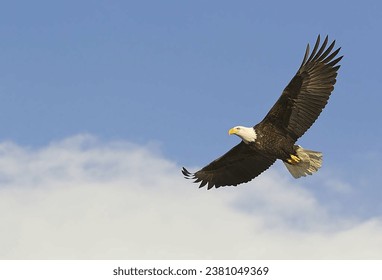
284;146;322;179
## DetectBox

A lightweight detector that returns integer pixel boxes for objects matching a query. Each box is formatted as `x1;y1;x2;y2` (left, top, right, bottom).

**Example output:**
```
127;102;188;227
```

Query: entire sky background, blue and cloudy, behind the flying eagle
0;0;382;259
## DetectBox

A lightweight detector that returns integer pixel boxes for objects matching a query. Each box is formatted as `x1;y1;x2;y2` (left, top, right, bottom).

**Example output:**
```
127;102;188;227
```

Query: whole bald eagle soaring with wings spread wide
182;36;342;189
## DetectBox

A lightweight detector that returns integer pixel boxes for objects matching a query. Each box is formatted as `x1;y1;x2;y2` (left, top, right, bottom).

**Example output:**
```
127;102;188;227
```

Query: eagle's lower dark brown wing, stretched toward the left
182;142;276;189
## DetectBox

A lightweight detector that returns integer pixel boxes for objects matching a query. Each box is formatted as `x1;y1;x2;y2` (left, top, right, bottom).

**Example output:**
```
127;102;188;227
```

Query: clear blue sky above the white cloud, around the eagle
0;1;382;256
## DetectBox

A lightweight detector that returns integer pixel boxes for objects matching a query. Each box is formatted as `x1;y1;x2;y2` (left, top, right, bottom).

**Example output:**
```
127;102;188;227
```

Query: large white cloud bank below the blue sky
0;136;382;259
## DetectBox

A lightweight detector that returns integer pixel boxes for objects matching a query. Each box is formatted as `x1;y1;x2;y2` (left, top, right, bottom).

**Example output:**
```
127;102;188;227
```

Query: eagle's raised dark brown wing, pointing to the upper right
262;36;342;140
